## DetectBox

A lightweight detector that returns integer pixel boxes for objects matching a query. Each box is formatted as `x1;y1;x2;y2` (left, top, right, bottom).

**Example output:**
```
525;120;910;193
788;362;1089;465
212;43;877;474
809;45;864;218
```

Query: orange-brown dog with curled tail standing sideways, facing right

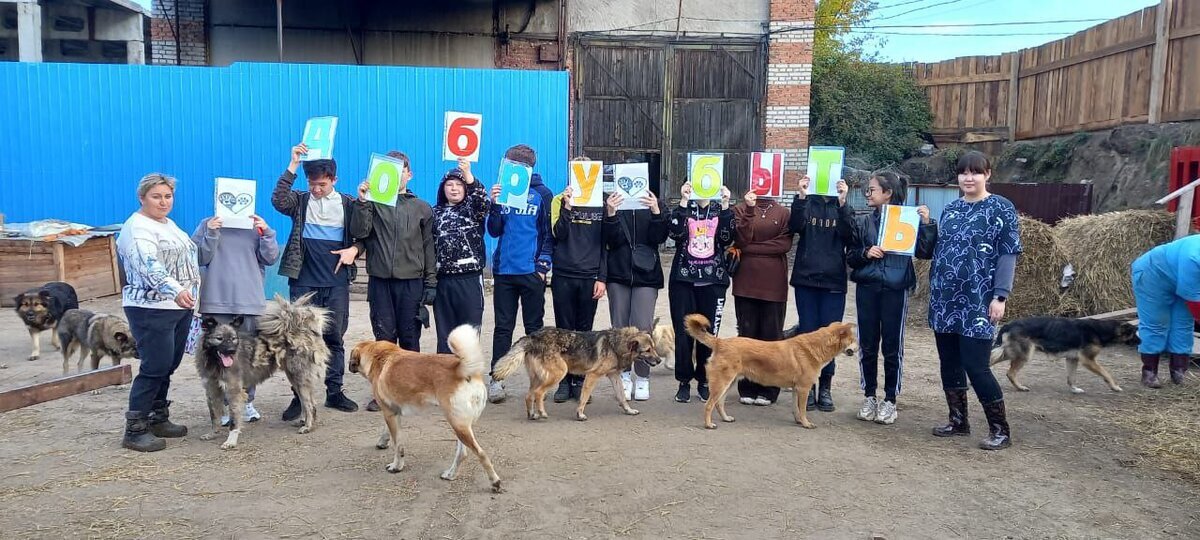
684;313;858;430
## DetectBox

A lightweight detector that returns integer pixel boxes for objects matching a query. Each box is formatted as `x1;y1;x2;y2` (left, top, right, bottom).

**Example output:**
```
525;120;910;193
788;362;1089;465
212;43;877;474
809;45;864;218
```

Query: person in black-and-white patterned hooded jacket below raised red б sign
433;158;492;354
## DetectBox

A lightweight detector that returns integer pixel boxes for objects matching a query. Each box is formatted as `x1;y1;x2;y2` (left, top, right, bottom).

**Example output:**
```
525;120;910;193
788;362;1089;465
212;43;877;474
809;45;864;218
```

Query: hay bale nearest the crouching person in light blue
1054;210;1175;316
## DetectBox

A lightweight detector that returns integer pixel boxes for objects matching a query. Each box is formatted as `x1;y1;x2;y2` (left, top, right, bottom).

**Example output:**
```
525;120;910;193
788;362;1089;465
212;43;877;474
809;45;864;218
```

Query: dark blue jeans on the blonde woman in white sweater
125;306;192;413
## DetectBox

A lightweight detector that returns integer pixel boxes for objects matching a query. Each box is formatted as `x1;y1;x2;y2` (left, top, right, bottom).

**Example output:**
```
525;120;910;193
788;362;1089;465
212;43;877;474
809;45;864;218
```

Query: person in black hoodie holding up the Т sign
787;176;854;413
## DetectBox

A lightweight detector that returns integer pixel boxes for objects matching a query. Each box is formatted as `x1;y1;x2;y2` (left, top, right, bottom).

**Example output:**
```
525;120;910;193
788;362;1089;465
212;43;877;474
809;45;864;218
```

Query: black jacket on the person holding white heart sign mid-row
604;200;667;289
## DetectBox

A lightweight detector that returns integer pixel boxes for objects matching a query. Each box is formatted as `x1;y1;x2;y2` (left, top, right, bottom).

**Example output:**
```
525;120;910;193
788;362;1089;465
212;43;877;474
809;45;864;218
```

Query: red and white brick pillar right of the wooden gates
763;0;816;193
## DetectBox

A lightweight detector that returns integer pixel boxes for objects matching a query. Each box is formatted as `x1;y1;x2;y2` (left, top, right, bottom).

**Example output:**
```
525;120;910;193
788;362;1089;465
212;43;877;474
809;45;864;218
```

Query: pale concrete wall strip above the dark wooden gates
566;0;769;35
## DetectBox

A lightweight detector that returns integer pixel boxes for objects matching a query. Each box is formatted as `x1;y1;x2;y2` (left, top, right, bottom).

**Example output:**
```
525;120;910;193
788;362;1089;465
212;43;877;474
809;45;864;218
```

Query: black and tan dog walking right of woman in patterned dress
991;317;1141;394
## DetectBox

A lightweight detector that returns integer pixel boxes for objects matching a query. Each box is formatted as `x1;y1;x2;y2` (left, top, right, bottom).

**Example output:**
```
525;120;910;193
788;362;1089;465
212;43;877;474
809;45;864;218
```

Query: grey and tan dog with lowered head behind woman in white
56;310;138;374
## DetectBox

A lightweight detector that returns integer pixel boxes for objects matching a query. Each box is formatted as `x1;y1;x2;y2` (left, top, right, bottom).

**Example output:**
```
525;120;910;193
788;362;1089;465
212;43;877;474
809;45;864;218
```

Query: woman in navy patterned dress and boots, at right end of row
929;151;1021;450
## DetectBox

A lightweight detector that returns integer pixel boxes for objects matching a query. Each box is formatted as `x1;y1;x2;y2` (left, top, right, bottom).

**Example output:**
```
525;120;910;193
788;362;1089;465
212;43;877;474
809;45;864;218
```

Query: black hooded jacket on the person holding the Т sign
787;196;854;293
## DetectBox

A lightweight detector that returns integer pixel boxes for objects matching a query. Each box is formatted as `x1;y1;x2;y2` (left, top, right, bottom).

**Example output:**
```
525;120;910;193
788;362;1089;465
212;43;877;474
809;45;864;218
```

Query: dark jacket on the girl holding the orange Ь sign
846;209;937;290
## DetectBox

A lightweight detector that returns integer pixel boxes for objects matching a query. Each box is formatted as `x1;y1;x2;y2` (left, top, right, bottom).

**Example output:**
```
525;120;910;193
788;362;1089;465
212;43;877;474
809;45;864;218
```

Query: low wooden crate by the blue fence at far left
0;236;121;307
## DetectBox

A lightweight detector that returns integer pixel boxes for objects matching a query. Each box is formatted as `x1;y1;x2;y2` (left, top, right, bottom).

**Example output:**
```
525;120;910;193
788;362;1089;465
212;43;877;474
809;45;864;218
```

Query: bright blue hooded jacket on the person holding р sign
487;173;554;276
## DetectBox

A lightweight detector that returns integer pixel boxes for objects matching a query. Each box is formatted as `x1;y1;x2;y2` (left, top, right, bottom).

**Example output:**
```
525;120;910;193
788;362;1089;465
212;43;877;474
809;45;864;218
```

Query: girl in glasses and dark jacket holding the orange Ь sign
846;172;937;424
